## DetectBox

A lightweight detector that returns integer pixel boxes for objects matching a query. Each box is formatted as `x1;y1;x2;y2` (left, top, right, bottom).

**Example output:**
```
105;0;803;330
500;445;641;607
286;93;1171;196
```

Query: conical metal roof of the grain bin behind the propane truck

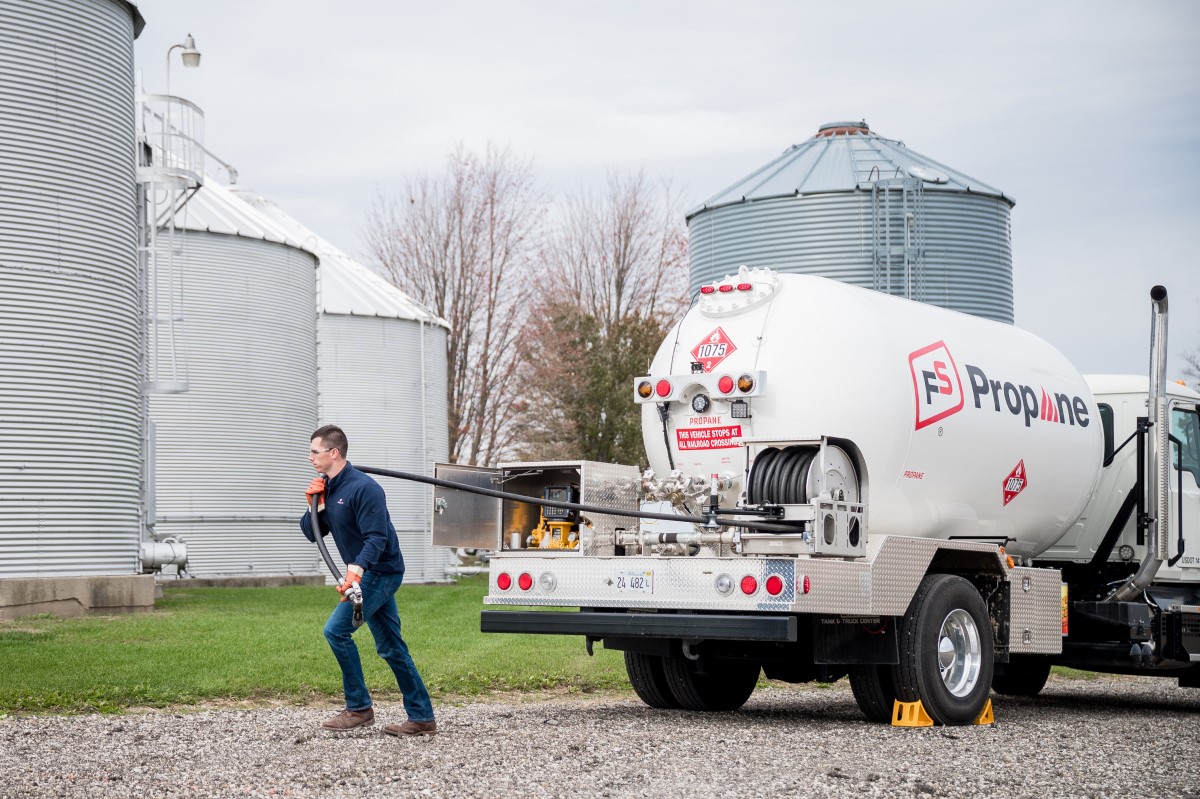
688;121;1013;220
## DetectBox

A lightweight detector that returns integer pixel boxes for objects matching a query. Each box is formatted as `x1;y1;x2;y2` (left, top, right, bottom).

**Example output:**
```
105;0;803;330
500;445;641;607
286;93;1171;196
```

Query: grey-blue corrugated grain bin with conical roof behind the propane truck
688;122;1013;323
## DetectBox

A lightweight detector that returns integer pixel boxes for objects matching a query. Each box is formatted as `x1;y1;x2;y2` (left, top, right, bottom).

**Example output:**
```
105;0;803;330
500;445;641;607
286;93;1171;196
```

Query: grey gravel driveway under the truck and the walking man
0;678;1200;799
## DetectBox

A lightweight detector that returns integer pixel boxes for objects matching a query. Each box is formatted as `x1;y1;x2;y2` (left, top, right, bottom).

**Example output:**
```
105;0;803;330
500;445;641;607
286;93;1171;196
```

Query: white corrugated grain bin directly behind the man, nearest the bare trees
239;192;452;582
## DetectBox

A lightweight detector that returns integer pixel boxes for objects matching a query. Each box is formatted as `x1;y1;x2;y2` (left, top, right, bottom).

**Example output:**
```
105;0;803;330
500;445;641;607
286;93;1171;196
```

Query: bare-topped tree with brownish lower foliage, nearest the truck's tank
518;173;688;463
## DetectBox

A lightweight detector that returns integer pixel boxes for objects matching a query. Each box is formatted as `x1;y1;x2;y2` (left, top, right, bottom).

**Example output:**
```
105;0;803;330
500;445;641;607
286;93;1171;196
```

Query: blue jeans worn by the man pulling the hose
325;571;433;721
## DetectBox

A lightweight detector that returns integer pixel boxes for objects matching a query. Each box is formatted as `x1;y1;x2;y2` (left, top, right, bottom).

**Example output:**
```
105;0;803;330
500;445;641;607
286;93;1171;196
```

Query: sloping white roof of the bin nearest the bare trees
234;188;449;328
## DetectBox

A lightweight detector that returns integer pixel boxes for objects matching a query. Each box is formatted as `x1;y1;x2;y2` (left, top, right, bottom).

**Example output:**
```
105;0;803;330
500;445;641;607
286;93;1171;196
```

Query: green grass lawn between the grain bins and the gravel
0;577;629;713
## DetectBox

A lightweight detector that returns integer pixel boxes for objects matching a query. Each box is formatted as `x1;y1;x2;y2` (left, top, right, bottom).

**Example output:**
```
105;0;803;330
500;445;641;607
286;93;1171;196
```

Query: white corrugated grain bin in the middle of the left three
150;180;324;577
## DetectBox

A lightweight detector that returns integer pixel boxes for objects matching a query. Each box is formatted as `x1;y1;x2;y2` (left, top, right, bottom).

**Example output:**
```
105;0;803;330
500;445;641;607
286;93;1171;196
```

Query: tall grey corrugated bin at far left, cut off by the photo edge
0;0;144;577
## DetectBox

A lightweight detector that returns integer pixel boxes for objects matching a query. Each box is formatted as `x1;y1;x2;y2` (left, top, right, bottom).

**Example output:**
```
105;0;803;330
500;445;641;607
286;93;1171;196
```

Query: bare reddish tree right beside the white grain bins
367;145;542;464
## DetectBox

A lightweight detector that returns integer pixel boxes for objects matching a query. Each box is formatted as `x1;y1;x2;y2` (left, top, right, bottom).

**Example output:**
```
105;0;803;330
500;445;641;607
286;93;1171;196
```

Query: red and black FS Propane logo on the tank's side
908;341;1092;429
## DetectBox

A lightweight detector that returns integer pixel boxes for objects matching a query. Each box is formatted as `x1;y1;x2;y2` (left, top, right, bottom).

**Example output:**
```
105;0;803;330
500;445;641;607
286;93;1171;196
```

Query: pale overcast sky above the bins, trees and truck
136;0;1200;379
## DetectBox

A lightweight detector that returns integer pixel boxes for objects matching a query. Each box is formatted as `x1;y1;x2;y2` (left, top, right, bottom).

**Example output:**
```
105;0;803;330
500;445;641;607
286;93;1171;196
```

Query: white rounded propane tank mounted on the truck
635;268;1104;557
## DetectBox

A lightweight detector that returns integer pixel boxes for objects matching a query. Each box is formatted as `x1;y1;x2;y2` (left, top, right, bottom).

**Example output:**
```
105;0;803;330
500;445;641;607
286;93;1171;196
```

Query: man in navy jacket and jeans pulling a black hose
300;425;438;735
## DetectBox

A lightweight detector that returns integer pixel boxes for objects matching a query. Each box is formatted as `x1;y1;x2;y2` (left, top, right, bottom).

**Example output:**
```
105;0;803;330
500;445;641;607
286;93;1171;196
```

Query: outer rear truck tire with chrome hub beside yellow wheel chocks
893;575;994;725
